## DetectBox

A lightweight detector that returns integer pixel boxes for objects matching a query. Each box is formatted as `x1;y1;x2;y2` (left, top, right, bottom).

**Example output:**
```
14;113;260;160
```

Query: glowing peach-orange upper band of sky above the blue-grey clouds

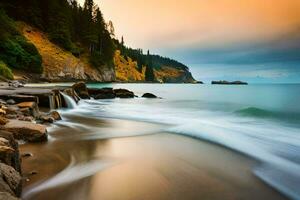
81;0;300;49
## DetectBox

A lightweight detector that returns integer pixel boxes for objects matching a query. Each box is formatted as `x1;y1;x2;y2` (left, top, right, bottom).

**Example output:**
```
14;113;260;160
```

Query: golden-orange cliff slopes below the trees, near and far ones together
15;24;196;83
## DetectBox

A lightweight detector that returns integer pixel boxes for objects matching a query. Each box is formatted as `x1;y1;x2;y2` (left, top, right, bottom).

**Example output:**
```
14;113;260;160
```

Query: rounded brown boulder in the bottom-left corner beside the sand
0;163;22;196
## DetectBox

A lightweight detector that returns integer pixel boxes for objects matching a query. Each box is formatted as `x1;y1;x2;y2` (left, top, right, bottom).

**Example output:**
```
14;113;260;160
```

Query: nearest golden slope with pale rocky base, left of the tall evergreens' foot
21;25;115;82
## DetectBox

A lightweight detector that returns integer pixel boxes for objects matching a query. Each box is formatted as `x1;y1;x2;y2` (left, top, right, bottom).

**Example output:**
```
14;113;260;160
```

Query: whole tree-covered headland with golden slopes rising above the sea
0;0;194;82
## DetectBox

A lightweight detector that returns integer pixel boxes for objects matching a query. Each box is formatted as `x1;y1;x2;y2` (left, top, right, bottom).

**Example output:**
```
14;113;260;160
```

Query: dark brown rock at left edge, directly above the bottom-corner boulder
0;131;21;172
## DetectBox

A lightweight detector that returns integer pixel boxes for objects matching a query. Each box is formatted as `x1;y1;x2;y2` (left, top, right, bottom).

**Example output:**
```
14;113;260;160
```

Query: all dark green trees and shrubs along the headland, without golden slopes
0;0;188;81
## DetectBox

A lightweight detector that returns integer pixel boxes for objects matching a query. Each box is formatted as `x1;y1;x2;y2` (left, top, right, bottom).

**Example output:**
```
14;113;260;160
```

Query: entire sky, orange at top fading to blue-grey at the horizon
80;0;300;82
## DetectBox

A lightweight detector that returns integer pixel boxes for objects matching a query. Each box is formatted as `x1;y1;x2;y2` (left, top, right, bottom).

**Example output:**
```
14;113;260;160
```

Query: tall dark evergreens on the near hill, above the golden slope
1;0;115;67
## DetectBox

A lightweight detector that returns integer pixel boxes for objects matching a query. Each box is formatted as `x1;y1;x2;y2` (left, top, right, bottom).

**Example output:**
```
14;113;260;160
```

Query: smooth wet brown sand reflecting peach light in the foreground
21;119;285;200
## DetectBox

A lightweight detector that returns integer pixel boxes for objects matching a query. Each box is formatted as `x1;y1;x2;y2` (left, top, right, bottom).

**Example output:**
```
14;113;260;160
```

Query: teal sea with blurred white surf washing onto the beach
29;84;300;199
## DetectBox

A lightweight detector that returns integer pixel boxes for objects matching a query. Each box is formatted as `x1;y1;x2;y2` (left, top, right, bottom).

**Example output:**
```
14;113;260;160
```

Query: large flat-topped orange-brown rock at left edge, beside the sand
0;120;47;142
